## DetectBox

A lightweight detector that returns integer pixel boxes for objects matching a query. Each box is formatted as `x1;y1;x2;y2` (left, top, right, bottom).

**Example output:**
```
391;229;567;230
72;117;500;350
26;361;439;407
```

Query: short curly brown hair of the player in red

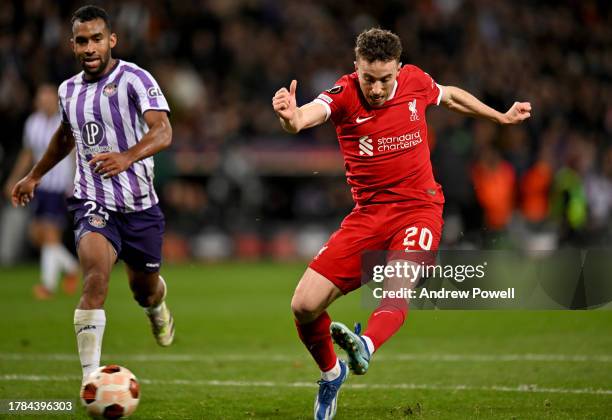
355;28;402;63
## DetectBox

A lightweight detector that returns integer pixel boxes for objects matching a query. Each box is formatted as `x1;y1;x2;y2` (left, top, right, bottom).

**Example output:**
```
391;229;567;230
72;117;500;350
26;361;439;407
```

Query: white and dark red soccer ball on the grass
81;365;140;419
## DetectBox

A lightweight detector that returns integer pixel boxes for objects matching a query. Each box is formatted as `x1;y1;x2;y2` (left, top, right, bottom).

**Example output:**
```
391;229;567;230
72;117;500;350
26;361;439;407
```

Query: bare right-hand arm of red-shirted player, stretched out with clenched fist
440;86;531;124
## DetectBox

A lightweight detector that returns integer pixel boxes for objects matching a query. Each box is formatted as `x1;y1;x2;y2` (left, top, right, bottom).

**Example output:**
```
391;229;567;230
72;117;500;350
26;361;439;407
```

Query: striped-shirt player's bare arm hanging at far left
11;124;74;207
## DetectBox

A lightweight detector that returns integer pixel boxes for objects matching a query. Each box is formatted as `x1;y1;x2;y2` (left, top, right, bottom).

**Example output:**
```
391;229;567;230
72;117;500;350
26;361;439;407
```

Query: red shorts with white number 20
309;202;444;294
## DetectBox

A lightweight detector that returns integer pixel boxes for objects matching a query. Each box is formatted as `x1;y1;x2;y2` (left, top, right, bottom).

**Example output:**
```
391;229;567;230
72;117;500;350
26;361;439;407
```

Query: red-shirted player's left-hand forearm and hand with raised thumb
272;80;327;134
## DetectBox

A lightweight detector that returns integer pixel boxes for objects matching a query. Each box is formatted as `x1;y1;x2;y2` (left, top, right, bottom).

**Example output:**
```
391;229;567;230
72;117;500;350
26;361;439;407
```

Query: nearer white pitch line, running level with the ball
0;375;612;395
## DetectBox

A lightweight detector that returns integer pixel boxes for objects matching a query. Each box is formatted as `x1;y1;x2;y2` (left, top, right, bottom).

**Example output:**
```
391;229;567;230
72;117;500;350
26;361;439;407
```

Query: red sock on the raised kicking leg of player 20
363;299;408;350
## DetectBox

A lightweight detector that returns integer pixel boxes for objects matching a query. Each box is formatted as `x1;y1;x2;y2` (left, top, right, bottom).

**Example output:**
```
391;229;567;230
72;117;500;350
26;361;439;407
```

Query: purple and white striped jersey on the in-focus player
58;60;170;213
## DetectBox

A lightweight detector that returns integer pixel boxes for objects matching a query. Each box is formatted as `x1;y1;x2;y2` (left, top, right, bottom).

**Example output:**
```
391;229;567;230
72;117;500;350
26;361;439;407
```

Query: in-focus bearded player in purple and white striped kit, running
12;6;174;384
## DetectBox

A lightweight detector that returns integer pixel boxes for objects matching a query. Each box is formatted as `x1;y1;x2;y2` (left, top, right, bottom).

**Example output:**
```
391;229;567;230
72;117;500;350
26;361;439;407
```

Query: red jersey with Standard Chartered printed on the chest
315;65;444;204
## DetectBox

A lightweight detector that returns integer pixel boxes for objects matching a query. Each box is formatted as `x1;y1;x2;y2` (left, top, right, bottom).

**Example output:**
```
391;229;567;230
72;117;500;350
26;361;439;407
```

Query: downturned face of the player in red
355;58;400;107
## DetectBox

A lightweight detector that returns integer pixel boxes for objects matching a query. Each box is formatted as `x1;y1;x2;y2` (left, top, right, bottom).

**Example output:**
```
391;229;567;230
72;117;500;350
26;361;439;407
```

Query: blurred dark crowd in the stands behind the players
0;0;612;259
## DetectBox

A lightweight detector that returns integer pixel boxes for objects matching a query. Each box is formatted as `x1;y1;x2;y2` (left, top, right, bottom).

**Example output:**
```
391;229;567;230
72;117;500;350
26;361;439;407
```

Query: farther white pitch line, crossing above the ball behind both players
0;352;612;363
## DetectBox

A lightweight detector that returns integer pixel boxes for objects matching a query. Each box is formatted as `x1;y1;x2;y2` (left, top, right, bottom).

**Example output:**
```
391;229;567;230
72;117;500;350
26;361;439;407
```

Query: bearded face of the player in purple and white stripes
71;18;117;78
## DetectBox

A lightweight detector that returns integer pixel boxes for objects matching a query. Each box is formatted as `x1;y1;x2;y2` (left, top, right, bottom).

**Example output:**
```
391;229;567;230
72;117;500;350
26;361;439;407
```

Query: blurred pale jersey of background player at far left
23;111;74;194
